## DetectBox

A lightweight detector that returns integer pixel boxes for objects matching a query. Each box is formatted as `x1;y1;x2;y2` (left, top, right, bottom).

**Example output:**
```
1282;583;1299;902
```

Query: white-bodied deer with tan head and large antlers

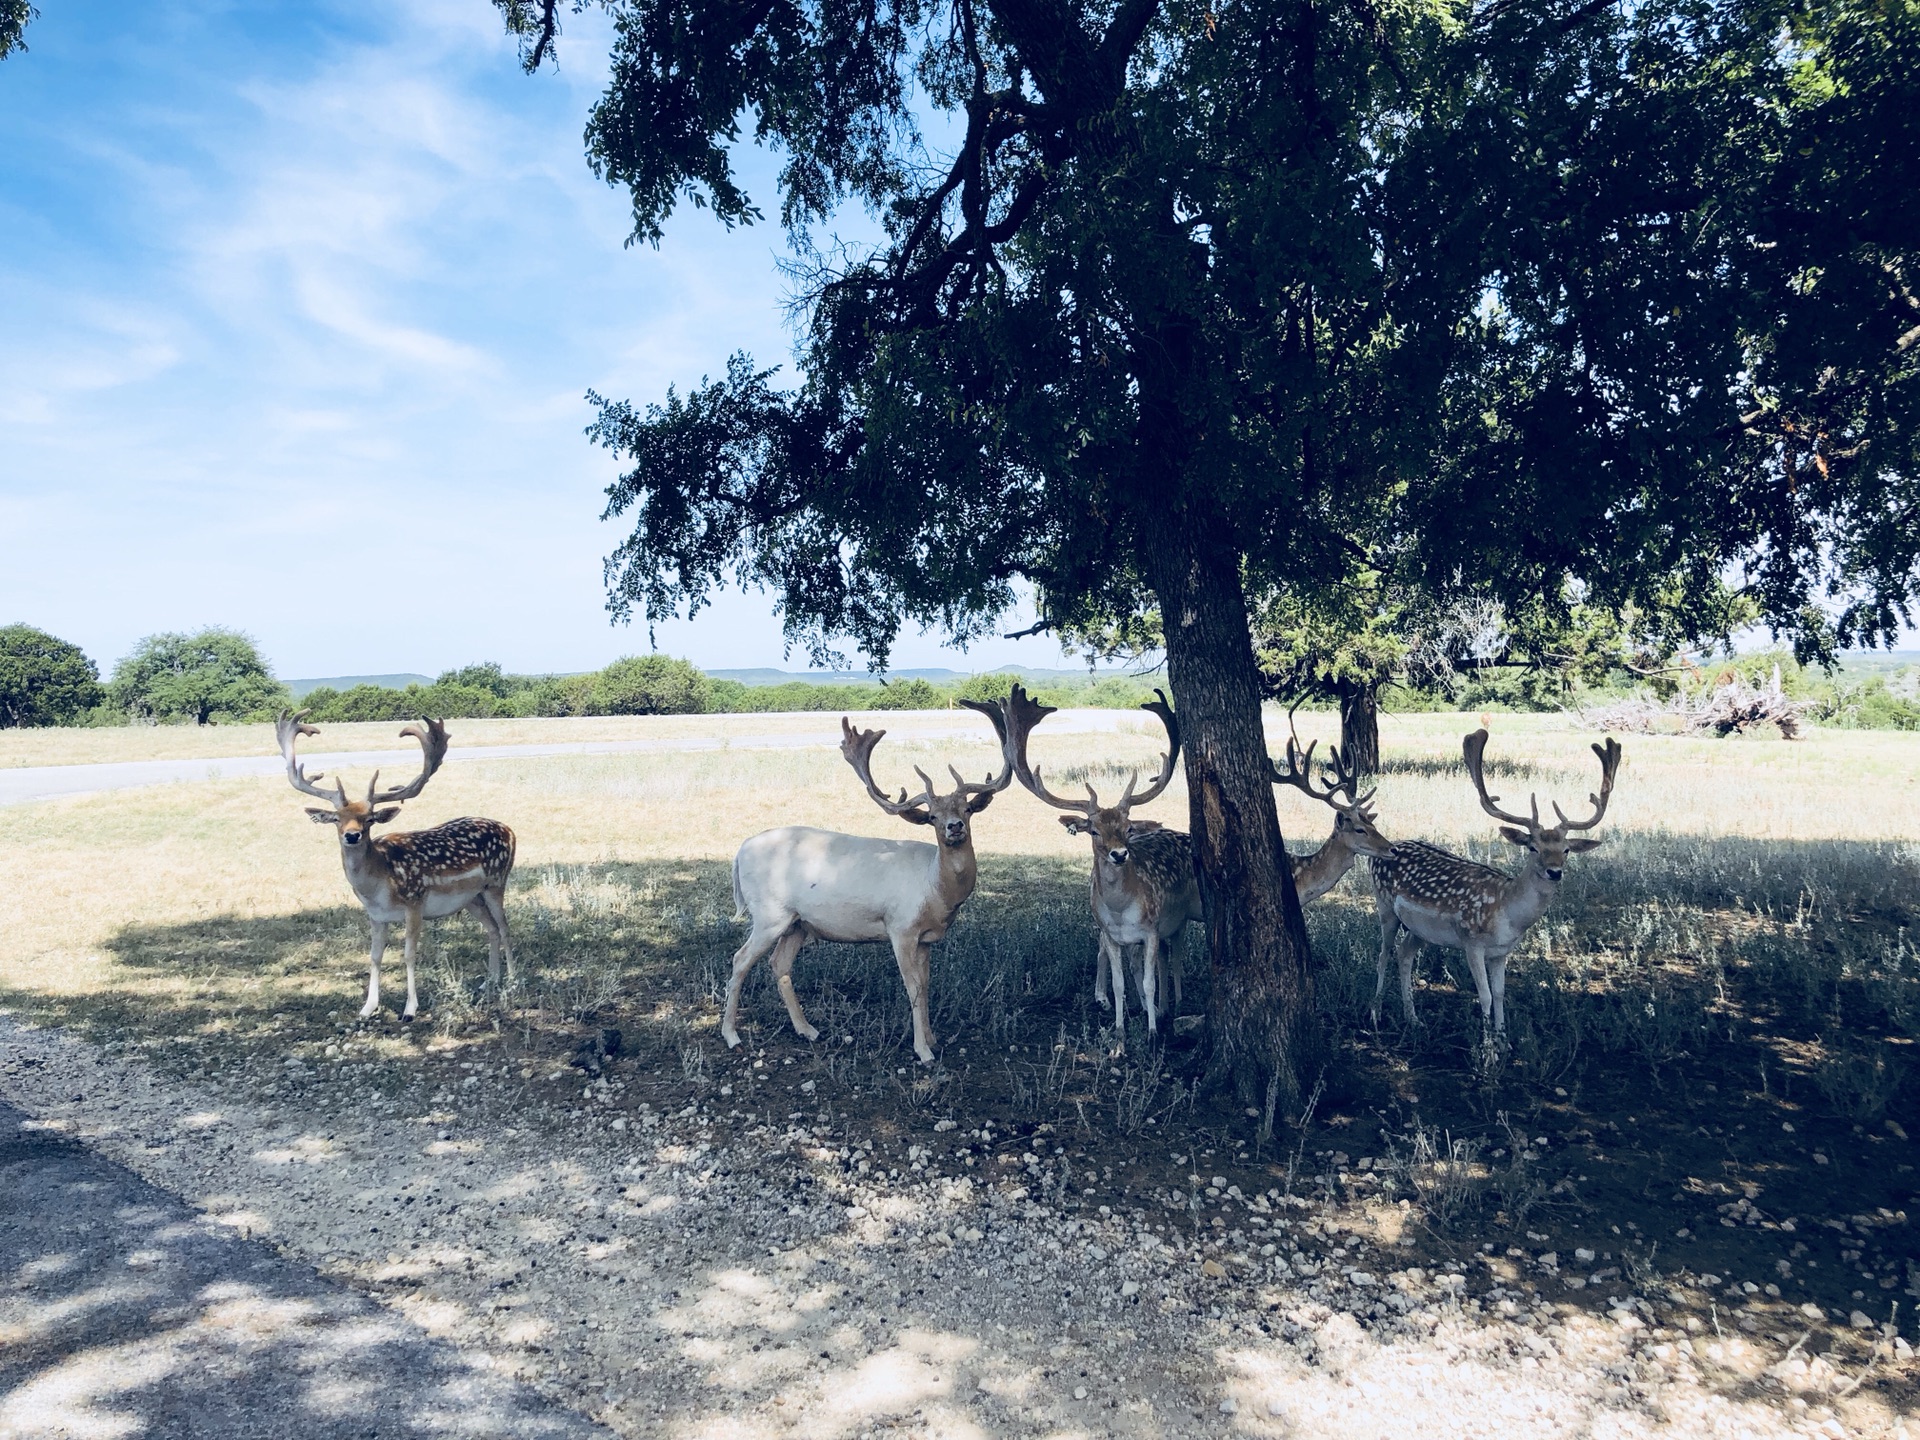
720;701;1014;1066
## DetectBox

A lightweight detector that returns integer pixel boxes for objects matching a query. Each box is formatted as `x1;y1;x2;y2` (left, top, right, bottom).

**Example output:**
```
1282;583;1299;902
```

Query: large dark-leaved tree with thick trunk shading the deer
495;0;1920;1100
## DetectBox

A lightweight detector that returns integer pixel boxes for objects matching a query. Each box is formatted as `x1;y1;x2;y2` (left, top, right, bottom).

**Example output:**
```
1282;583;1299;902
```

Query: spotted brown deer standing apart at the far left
278;712;513;1021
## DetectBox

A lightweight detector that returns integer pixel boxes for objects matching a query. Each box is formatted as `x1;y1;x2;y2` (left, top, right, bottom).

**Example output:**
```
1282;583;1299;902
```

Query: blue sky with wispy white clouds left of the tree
0;0;1062;676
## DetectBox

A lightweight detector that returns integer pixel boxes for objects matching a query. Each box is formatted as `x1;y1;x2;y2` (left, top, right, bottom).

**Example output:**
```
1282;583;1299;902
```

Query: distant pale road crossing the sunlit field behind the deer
0;710;1133;804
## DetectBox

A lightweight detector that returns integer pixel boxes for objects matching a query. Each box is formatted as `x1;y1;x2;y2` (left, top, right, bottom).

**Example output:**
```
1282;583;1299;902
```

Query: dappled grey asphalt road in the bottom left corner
0;1104;611;1440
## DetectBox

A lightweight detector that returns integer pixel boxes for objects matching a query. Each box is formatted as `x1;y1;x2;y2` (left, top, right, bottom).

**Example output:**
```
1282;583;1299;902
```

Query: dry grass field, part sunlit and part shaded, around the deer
0;716;1920;1432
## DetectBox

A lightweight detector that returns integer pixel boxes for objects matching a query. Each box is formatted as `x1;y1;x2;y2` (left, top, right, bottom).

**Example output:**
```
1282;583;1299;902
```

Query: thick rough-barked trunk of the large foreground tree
1139;513;1315;1114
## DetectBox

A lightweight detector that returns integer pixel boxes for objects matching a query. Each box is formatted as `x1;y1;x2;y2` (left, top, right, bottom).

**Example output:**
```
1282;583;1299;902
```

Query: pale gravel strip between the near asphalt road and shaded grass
0;1021;1881;1440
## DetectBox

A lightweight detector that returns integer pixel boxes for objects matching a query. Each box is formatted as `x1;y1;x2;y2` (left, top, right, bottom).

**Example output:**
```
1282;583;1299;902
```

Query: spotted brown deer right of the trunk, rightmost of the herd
1373;730;1620;1035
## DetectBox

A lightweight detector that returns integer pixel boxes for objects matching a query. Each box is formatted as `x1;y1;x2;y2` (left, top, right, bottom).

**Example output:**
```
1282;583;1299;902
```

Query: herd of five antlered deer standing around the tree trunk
278;685;1620;1064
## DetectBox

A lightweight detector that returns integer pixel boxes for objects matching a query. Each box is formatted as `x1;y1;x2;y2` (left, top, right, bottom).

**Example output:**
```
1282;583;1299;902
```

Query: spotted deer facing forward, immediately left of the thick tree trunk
1006;685;1202;1043
